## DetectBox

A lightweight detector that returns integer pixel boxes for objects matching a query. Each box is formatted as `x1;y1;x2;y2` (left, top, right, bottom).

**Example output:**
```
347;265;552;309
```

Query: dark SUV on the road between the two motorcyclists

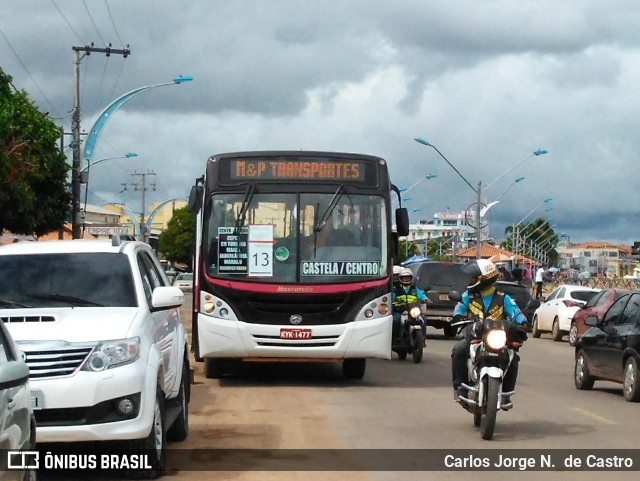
414;261;469;337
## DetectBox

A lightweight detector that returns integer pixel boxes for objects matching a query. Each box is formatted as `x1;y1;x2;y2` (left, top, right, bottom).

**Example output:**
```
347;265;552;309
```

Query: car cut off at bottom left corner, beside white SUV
0;316;36;481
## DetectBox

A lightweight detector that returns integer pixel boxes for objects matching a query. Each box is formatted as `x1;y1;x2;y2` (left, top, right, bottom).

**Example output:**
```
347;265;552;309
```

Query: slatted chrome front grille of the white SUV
19;342;95;379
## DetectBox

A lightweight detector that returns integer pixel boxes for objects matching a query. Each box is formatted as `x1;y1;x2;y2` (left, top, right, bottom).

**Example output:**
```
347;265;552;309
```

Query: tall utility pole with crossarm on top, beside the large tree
71;43;131;239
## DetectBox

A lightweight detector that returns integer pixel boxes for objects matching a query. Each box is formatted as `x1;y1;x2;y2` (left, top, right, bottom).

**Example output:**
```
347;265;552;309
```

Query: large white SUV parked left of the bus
0;237;190;478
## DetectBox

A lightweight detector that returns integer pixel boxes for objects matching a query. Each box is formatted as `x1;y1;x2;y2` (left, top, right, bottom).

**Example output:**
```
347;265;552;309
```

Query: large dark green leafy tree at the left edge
0;69;71;235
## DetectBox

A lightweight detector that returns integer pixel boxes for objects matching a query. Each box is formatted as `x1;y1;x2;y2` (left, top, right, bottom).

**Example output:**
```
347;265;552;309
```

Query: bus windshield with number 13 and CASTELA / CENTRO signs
202;190;389;284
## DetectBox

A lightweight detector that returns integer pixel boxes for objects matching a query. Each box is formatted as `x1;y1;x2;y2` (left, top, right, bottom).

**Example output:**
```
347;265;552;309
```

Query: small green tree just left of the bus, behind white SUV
158;207;196;265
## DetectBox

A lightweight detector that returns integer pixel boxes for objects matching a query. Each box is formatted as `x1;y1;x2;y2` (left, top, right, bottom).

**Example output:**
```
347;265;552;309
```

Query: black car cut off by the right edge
574;290;640;402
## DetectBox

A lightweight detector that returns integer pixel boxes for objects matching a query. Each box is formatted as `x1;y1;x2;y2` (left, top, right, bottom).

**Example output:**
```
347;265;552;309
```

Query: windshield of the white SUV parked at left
0;252;137;308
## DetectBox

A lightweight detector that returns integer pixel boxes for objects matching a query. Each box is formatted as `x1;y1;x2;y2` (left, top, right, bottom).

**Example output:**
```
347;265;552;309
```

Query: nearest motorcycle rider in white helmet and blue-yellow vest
451;259;527;402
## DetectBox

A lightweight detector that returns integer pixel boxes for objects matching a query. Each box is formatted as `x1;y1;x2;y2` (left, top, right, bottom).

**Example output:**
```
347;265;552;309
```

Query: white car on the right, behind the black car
532;284;600;341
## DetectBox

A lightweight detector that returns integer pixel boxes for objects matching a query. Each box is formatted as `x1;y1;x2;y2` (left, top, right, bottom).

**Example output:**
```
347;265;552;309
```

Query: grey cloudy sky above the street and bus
0;0;640;244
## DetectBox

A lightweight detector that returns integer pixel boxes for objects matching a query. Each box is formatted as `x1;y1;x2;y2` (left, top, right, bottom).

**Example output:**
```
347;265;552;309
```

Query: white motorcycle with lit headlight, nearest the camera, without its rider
452;317;522;440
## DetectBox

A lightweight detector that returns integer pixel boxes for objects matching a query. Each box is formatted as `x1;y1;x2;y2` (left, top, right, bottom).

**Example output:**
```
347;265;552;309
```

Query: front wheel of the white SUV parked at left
126;387;167;479
